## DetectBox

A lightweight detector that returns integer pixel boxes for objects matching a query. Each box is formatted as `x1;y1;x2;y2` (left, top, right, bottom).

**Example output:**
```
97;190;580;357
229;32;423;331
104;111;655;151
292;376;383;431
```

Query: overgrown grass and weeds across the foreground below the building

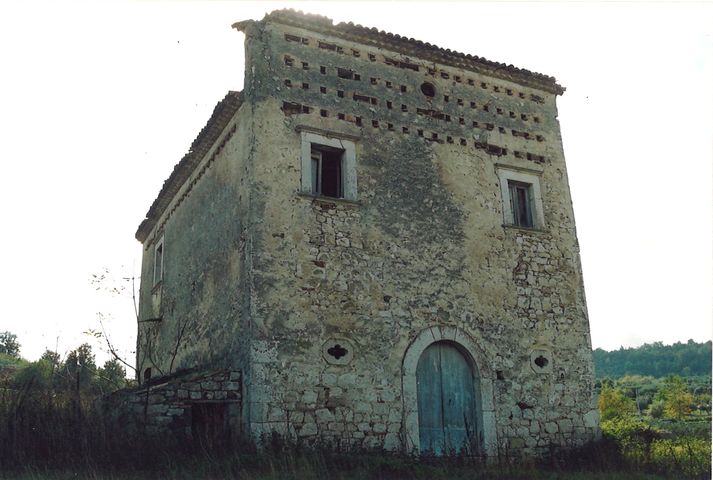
0;388;711;480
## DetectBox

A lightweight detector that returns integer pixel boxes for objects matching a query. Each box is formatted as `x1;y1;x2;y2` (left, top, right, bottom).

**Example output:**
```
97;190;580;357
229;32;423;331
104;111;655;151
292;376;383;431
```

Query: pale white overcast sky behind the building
0;1;713;368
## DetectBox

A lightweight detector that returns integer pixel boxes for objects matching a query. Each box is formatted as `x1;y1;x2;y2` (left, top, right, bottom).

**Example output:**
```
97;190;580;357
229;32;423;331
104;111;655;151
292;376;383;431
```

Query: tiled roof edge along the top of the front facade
233;9;564;95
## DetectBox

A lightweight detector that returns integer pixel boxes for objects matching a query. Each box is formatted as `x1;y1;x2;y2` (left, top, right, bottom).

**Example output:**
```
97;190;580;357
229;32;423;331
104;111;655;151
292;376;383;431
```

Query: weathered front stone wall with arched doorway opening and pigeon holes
238;16;597;455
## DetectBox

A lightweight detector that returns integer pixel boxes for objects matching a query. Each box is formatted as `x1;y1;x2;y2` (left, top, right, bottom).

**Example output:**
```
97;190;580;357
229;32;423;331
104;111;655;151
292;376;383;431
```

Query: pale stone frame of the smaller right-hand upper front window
497;166;545;230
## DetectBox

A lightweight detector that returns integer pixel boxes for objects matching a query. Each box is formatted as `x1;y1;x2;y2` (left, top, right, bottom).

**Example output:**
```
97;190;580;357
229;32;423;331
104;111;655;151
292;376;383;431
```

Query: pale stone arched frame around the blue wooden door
401;326;497;457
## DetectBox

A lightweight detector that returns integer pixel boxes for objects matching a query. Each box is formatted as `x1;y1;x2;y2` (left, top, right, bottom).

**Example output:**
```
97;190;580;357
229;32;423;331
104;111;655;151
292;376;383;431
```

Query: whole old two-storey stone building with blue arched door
131;10;598;457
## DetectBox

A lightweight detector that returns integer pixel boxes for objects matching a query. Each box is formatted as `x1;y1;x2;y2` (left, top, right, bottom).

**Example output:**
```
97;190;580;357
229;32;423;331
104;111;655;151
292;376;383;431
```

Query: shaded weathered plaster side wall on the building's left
138;109;250;376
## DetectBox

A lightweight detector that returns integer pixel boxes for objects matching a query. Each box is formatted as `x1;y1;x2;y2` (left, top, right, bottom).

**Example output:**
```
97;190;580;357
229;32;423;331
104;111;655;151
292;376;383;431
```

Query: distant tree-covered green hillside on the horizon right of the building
594;340;711;378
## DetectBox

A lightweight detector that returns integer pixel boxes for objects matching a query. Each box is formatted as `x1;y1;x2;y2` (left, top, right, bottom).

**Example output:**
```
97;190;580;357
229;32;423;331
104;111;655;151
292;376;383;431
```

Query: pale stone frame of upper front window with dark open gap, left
300;131;357;201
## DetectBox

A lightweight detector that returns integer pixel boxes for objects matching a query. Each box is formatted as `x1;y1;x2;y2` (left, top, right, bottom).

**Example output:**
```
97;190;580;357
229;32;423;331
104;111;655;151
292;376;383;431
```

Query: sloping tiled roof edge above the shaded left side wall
136;91;243;242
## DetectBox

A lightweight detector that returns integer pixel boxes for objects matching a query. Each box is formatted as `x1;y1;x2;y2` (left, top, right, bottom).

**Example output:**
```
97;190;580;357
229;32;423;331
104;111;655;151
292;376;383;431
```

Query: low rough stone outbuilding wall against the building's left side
104;370;241;441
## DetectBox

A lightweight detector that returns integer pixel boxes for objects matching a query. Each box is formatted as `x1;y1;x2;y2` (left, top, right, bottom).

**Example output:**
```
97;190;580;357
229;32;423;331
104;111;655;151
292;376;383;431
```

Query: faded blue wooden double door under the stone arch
416;342;476;455
